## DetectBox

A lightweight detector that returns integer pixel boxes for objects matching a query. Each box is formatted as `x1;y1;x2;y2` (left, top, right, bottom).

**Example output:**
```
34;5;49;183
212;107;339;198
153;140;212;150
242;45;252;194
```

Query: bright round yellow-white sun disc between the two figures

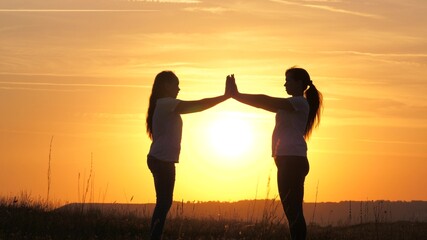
207;115;254;159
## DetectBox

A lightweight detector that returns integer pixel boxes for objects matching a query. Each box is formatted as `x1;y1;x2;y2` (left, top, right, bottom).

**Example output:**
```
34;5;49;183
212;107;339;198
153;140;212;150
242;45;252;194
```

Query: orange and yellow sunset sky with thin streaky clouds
0;0;427;203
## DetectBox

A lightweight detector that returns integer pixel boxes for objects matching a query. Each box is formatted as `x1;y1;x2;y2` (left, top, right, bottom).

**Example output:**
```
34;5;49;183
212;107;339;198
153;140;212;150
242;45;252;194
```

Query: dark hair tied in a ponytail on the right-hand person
285;67;323;139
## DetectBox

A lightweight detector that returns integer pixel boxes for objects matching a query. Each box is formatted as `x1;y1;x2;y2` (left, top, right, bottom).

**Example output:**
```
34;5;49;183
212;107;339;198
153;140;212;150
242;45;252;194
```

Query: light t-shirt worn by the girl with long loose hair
148;97;182;163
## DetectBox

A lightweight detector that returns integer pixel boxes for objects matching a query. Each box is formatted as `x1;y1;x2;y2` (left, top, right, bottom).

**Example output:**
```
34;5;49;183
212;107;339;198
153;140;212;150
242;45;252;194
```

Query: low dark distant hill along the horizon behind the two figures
56;200;427;226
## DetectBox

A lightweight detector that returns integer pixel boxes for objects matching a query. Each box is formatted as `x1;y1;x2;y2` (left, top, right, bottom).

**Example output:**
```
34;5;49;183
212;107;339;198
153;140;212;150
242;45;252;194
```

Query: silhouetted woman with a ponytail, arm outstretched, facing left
227;67;322;240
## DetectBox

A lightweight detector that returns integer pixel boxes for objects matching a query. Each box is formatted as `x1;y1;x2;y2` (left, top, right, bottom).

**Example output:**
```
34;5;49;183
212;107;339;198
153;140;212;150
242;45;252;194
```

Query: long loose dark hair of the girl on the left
146;71;179;139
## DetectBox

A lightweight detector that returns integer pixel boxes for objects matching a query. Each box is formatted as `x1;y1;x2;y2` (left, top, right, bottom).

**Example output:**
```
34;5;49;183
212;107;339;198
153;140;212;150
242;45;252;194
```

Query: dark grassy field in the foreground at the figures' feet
0;196;427;240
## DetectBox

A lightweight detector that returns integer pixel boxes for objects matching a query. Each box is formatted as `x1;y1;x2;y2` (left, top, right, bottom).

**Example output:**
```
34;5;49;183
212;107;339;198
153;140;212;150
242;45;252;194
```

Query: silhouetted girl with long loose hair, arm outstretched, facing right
146;71;229;240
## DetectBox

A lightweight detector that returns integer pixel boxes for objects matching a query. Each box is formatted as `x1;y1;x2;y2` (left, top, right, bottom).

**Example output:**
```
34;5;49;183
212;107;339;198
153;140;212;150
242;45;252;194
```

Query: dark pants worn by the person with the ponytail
274;156;309;240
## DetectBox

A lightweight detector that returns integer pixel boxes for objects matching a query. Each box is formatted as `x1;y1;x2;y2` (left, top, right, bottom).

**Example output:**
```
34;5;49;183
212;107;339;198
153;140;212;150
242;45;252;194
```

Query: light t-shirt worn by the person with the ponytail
272;96;310;157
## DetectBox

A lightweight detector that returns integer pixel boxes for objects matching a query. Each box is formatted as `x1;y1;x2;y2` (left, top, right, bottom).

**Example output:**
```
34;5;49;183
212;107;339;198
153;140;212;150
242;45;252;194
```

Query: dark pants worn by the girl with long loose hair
147;156;175;240
